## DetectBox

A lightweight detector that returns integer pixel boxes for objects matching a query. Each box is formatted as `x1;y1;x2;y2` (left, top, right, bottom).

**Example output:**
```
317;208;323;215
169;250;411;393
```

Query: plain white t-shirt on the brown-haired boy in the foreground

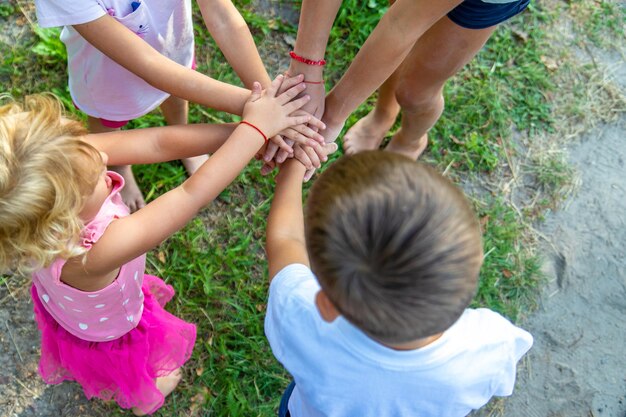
265;264;533;417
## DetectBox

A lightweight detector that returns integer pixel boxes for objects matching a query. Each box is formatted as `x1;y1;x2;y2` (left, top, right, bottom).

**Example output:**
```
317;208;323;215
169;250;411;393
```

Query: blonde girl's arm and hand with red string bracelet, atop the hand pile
82;76;310;277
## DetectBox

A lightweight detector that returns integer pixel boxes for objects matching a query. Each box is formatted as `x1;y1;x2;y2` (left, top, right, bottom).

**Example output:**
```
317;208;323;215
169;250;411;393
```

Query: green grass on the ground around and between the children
0;0;625;416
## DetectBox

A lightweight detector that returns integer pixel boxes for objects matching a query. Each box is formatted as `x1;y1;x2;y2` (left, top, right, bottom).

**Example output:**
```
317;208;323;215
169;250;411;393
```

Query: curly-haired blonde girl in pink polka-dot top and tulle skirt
0;76;320;415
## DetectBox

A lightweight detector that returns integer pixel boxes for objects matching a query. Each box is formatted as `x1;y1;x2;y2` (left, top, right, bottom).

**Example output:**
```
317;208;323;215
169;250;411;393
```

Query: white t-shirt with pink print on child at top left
35;0;194;121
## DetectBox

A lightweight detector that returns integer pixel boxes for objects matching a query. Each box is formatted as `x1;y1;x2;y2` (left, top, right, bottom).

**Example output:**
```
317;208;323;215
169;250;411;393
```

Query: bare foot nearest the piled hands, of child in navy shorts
343;110;395;155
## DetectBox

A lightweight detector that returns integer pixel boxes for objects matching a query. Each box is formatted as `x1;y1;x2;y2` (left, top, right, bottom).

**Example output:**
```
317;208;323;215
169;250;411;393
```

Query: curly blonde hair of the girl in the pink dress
0;95;102;274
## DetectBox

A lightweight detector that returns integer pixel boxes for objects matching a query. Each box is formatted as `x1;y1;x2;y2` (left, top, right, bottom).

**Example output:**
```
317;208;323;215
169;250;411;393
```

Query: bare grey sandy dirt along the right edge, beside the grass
504;117;626;417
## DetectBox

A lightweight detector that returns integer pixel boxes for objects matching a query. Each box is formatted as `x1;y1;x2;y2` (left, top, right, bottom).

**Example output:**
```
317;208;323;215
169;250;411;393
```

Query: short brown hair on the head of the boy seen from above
305;151;482;344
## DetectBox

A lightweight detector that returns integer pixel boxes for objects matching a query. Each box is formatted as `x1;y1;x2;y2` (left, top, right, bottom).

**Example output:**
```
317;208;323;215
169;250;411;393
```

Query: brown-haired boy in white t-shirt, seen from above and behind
265;151;532;417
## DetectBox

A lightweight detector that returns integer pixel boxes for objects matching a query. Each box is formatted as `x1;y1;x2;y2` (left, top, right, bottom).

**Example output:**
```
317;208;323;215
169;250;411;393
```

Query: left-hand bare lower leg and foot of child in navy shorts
343;70;400;155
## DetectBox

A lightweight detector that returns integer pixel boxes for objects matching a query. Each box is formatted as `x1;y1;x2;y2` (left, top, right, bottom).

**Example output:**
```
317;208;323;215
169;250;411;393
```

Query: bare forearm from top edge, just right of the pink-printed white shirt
198;0;270;88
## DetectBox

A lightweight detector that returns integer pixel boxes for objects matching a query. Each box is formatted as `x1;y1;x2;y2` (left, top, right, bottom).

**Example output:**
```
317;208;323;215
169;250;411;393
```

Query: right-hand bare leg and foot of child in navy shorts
386;17;496;159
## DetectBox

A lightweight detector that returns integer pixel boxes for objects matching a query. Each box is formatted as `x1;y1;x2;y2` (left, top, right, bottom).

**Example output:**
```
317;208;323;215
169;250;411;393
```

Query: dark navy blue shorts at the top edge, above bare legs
448;0;530;29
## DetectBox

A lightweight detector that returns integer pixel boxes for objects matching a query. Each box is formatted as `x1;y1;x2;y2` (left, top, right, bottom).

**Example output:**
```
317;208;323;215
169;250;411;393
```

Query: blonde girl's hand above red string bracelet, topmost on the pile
243;75;311;137
